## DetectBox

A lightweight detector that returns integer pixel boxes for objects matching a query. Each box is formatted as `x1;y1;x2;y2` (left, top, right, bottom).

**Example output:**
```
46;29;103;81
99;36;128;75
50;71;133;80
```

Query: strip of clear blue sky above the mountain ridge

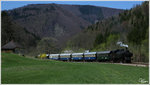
1;1;143;10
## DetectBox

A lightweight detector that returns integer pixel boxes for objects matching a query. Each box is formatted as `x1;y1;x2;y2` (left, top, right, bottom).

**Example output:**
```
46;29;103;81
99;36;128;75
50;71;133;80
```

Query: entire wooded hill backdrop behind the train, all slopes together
2;2;149;62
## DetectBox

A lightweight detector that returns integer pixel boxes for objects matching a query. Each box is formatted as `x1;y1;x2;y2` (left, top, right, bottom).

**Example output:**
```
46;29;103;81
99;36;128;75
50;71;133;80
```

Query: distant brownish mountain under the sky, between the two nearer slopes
7;4;123;47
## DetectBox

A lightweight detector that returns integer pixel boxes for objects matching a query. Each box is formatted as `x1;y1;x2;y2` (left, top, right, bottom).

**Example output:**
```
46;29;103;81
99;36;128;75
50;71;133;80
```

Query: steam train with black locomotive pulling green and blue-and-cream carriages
47;49;133;63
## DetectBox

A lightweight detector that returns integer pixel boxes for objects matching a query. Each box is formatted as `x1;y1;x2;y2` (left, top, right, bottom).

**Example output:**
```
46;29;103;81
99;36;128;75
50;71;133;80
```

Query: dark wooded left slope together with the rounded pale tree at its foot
1;11;61;55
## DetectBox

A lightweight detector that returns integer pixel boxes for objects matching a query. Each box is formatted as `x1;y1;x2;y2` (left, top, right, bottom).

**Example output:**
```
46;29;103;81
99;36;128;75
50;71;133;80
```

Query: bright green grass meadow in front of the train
1;53;149;84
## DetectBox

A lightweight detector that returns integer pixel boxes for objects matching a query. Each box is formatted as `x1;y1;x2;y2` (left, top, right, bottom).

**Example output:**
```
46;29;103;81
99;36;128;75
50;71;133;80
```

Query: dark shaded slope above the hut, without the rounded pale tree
1;11;40;53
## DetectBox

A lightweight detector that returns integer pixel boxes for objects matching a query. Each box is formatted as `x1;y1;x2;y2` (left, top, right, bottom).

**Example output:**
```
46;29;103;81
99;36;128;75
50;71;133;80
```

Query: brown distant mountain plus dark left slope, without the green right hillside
2;4;123;55
